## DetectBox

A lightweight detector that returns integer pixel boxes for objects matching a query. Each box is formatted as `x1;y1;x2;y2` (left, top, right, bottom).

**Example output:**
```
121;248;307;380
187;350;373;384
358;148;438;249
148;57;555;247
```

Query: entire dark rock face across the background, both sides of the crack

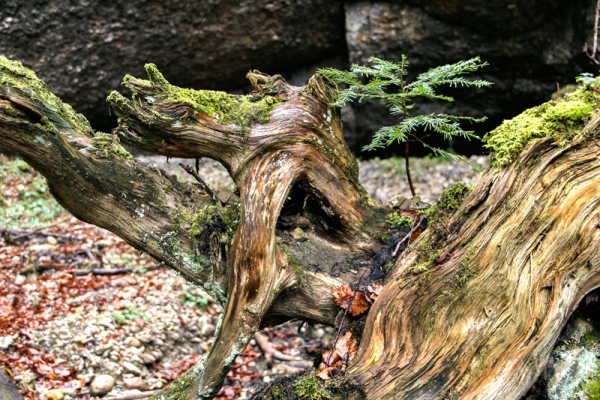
0;0;597;153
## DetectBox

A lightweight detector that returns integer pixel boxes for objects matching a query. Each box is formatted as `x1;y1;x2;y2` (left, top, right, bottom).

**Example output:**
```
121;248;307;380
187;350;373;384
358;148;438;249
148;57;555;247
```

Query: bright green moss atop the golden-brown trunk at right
483;78;600;168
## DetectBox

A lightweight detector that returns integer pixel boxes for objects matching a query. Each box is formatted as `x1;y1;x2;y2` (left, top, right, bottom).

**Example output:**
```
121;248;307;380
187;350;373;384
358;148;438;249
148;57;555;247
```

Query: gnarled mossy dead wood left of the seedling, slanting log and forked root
0;59;386;399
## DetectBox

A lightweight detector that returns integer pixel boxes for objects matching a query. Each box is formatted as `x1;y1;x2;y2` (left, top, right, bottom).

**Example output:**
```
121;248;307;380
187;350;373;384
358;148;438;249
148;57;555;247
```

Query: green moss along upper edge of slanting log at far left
0;56;92;136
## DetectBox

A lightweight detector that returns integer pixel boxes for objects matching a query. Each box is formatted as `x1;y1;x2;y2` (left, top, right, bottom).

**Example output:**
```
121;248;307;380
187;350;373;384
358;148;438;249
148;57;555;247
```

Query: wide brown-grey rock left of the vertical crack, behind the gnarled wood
0;0;346;130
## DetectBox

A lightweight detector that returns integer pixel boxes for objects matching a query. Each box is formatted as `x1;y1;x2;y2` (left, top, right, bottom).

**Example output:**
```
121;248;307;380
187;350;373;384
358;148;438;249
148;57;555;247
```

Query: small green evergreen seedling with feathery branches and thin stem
317;54;490;196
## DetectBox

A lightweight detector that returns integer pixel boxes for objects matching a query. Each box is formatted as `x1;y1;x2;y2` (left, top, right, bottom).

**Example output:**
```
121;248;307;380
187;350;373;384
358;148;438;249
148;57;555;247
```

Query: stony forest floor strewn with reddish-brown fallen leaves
0;154;486;400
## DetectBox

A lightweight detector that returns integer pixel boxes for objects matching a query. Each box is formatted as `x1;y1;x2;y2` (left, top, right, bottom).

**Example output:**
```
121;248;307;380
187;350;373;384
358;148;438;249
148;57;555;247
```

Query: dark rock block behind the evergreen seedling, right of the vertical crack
345;0;598;151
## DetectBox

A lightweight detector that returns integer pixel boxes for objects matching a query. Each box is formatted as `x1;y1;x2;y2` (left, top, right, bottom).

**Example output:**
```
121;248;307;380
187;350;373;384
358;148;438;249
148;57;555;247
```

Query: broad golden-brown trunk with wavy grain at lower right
350;123;600;399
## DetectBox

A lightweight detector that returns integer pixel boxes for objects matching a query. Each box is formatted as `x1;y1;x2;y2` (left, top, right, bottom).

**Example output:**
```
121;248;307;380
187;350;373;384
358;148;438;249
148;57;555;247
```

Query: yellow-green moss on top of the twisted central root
136;64;283;133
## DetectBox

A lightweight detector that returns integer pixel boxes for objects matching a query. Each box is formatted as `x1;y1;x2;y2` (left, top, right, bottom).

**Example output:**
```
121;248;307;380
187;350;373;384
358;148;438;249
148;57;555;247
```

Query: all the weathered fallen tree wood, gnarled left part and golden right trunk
0;55;600;399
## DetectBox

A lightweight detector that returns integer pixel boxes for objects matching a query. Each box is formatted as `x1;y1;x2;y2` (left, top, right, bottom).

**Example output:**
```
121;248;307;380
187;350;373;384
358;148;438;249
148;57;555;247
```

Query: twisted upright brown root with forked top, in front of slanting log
110;66;385;398
